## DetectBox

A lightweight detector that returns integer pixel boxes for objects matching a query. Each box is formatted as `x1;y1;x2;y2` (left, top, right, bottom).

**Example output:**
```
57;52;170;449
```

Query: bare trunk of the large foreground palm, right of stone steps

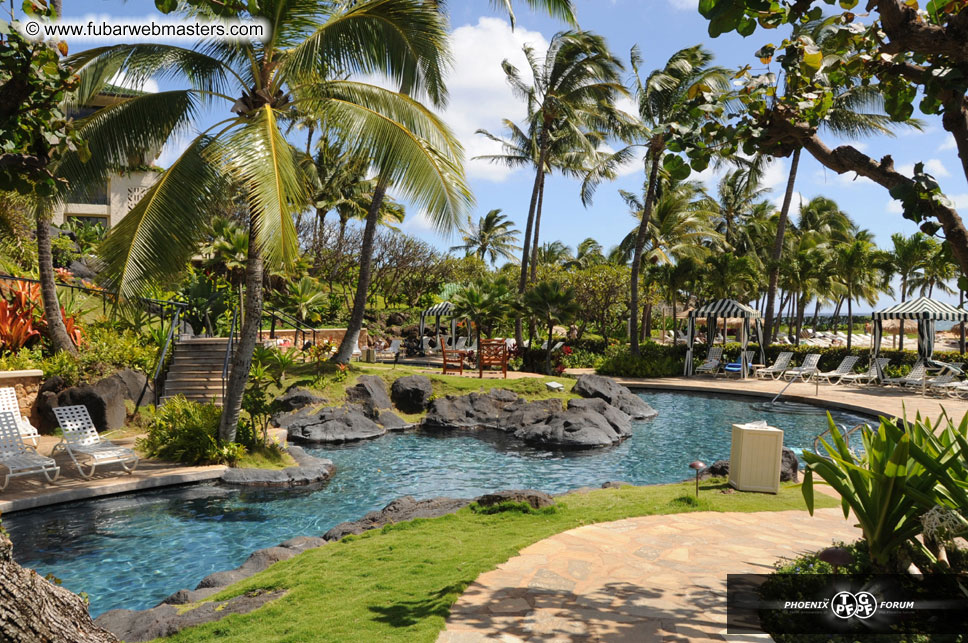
218;219;263;443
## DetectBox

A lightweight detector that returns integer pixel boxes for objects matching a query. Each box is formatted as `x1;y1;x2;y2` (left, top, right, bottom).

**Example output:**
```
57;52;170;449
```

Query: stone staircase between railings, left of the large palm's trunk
161;337;229;405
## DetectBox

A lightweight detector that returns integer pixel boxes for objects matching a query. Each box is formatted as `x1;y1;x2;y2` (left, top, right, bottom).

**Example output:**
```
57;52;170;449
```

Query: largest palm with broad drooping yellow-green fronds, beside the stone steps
71;0;470;441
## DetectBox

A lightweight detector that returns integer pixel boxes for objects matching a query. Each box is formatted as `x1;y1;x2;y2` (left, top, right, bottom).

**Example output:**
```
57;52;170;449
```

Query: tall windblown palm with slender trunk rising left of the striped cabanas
582;45;730;355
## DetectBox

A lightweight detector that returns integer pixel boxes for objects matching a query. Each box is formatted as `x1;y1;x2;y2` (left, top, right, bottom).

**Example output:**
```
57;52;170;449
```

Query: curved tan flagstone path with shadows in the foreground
437;508;860;643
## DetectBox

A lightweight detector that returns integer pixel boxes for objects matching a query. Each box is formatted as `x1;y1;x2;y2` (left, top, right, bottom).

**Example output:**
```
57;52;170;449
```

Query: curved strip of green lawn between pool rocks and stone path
155;480;837;643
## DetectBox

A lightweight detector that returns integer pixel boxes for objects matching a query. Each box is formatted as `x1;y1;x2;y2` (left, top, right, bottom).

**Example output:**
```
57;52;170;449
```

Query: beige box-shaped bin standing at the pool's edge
729;422;783;493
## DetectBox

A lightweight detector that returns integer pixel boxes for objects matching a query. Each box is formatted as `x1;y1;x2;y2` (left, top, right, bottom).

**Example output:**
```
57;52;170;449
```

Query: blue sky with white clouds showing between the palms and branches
39;0;968;308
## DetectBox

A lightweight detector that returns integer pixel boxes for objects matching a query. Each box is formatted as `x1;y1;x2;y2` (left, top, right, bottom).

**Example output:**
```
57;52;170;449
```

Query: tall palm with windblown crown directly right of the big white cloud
481;31;625;345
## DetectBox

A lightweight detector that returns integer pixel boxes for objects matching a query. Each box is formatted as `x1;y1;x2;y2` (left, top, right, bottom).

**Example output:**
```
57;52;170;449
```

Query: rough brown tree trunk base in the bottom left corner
0;531;119;643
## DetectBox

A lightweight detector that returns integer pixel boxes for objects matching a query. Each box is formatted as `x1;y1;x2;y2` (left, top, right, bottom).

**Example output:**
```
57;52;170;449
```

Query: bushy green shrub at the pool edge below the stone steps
138;396;245;465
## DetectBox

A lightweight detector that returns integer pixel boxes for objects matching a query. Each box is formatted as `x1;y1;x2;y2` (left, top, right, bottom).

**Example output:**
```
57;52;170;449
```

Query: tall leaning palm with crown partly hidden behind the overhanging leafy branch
764;18;921;348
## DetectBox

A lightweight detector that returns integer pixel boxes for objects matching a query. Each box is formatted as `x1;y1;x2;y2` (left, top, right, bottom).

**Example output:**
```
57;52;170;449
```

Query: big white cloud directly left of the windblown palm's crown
443;17;548;182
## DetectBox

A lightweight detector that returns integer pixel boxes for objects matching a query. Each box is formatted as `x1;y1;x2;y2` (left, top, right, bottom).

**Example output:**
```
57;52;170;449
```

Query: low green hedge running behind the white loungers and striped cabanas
597;342;968;377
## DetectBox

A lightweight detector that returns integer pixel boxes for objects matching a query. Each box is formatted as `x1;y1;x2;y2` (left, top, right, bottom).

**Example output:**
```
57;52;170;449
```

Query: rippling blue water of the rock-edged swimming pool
3;393;864;616
